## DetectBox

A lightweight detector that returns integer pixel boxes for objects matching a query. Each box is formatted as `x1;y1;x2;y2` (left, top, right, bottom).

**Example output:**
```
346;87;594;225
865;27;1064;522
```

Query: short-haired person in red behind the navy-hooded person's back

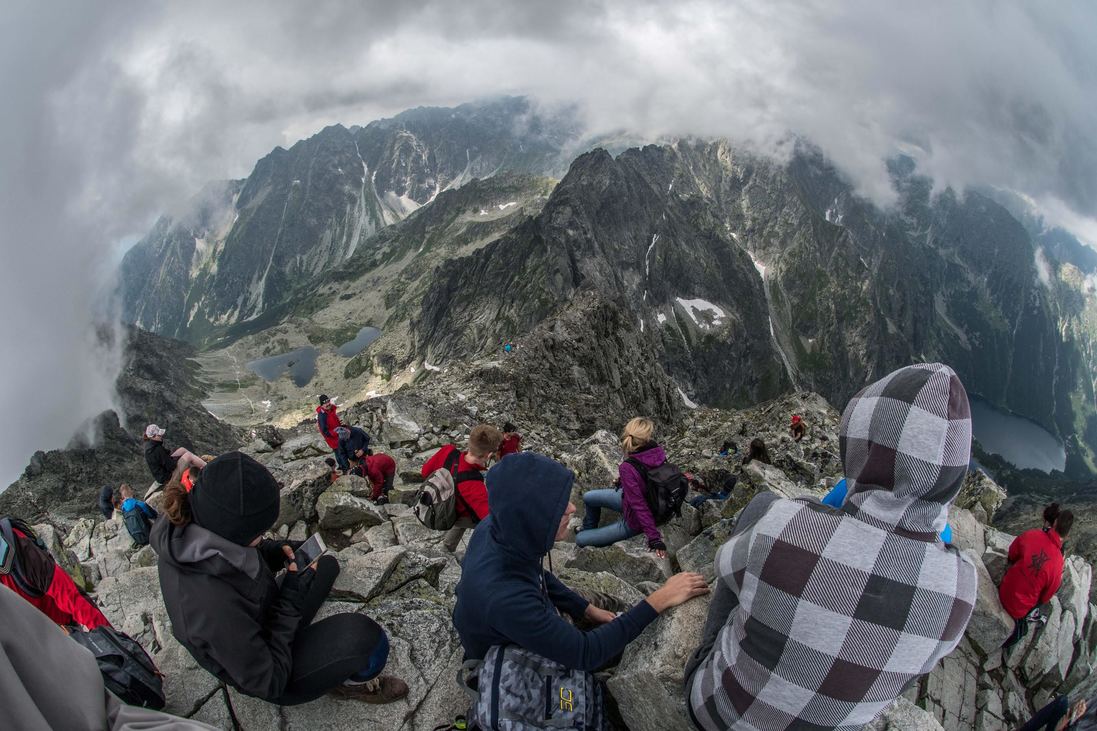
422;424;502;553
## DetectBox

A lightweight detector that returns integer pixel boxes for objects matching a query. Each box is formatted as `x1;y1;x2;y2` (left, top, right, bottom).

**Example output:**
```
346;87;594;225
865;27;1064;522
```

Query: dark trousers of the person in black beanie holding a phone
271;555;388;706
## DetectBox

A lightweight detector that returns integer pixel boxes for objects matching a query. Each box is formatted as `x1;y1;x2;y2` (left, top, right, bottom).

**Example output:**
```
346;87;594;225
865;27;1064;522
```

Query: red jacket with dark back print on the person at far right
998;528;1063;619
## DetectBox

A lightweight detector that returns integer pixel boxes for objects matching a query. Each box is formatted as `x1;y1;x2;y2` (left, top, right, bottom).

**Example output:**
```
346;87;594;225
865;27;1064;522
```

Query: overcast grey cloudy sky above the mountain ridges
0;0;1097;484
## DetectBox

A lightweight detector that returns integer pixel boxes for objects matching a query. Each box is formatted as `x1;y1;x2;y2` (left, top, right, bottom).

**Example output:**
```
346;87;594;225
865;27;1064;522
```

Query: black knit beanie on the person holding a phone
190;452;280;546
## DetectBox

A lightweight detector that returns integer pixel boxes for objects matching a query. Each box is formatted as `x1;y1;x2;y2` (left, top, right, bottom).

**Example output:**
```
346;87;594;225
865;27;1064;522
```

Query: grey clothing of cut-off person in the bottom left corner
0;588;220;731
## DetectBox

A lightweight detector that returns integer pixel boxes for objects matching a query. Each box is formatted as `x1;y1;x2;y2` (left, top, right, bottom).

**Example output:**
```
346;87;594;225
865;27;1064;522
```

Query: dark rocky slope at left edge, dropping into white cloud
0;328;240;521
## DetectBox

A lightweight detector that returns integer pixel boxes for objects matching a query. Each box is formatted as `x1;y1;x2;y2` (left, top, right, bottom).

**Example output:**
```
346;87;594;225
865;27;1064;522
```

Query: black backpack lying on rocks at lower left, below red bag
69;625;163;710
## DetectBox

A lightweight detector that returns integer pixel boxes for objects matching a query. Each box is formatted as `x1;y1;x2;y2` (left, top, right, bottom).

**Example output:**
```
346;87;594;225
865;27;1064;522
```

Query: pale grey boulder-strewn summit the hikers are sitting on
10;351;1097;731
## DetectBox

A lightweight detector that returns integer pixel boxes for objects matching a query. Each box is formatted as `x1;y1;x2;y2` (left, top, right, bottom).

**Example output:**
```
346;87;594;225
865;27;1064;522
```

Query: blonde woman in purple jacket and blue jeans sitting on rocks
575;416;667;559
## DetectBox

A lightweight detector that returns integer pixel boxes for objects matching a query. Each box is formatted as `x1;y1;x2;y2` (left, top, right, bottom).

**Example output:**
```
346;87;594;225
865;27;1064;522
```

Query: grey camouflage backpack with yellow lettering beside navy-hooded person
468;644;607;731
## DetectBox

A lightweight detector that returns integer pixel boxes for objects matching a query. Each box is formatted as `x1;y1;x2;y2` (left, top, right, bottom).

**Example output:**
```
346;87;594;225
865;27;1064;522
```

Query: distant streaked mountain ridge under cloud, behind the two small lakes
122;99;575;342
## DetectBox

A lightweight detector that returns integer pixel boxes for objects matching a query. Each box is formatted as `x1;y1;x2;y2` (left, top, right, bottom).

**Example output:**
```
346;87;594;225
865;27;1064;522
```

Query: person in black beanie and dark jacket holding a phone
150;452;408;706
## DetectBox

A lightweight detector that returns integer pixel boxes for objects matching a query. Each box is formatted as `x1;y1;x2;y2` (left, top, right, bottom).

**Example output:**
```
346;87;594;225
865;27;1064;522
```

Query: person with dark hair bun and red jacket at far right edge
998;503;1074;649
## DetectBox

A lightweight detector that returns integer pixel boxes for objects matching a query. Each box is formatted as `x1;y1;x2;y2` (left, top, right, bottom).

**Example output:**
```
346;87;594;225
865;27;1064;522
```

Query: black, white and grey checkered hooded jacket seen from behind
688;363;976;731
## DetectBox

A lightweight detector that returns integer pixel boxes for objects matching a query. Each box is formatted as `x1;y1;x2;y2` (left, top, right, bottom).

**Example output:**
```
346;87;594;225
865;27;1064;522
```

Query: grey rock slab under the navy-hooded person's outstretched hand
609;596;709;731
